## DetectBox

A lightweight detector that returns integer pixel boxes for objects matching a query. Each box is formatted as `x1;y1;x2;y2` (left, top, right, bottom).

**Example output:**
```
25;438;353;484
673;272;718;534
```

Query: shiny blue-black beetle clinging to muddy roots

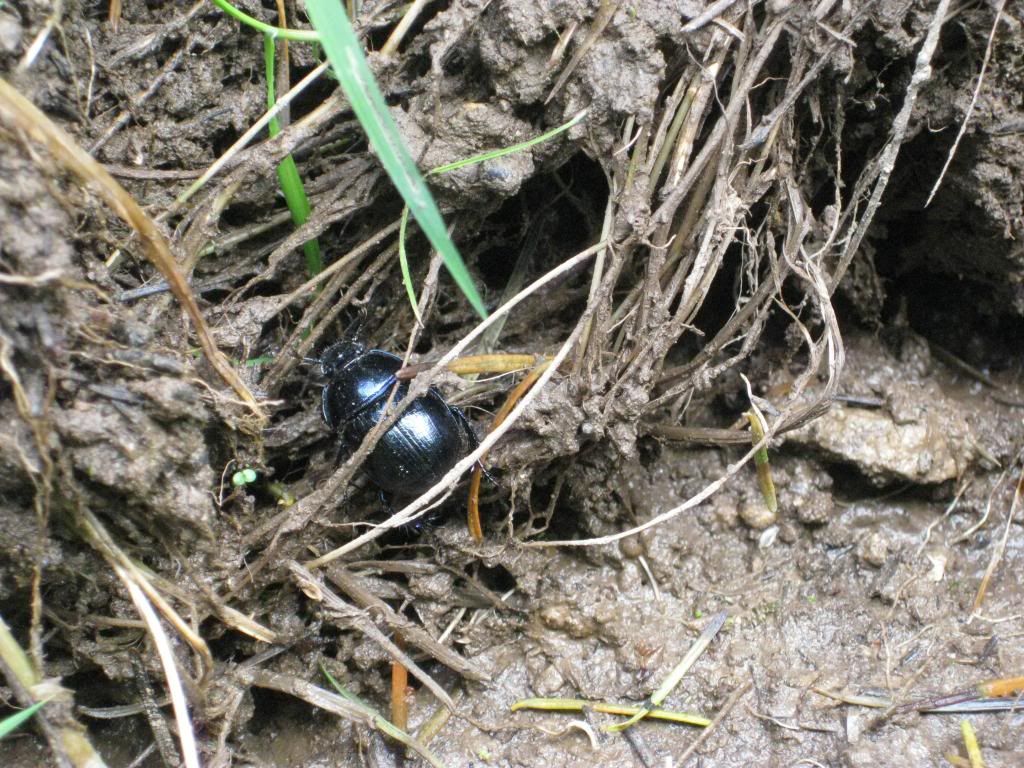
319;340;477;497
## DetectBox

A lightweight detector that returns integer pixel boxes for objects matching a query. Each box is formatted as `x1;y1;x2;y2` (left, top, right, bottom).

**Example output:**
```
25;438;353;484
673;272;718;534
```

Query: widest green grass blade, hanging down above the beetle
306;0;487;317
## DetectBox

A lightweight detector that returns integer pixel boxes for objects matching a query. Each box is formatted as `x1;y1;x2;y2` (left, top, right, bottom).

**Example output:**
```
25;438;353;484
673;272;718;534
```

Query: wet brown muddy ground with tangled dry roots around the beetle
0;0;1024;768
